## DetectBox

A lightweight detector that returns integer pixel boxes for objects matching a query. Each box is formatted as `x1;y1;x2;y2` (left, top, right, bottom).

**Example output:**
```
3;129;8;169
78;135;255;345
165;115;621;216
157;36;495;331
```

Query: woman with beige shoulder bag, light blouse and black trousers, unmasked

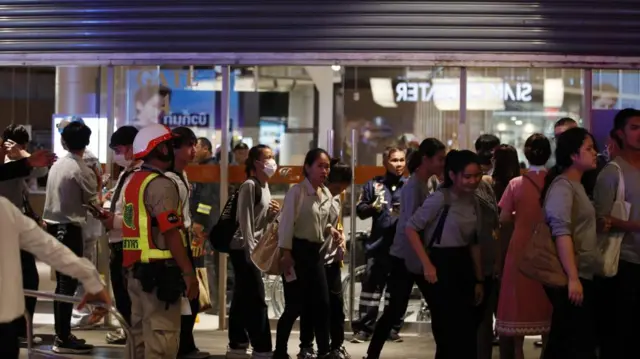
273;148;343;359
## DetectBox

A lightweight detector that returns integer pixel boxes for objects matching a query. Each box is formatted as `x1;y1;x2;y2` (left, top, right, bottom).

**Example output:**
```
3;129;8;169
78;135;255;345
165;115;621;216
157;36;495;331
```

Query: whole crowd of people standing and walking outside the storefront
0;109;640;359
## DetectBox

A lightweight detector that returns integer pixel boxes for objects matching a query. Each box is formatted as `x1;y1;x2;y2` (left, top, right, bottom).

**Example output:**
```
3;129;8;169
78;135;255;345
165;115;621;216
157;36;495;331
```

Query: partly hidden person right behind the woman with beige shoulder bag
298;159;353;359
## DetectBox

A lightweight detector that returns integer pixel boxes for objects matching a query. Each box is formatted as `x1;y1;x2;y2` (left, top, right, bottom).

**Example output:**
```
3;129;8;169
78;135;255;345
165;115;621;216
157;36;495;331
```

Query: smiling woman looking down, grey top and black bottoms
404;150;484;359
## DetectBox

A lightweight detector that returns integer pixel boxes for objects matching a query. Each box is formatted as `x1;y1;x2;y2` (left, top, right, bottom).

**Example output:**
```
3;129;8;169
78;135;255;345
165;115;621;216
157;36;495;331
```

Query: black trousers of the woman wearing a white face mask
229;250;272;353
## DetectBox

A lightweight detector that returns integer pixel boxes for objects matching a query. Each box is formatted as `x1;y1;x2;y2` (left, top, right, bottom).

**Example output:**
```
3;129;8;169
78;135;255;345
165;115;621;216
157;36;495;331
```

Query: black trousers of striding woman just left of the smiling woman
367;256;428;359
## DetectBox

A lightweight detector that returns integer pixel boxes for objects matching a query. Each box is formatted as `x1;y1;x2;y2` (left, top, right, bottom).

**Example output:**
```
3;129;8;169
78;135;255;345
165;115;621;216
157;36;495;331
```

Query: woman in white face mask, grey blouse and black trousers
227;145;280;358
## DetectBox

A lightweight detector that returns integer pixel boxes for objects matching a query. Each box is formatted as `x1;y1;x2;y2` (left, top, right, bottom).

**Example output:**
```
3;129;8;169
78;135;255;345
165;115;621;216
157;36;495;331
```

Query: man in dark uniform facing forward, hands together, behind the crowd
352;148;406;343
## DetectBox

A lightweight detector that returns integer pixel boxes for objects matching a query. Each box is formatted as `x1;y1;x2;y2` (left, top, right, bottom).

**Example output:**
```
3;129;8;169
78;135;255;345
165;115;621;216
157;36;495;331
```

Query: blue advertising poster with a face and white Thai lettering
127;69;239;129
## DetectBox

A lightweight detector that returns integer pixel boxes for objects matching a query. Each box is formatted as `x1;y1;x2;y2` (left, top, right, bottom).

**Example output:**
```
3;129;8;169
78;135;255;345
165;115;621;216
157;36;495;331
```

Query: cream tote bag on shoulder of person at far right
598;162;631;277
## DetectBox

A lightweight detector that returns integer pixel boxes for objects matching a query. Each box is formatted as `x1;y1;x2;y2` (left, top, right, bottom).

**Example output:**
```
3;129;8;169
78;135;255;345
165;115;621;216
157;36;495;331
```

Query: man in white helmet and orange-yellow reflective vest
104;124;198;359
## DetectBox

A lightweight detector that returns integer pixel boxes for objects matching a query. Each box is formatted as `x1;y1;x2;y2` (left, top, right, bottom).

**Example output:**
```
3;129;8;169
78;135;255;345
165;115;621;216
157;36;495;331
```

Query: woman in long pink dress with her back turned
496;133;552;359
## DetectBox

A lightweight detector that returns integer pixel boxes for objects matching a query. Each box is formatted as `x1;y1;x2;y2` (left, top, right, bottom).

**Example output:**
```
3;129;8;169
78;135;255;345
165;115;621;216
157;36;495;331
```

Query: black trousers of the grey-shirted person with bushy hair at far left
47;224;84;340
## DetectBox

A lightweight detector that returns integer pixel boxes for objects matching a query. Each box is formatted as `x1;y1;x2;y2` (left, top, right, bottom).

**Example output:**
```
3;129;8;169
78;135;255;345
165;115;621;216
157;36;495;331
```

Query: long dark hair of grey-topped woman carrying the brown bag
540;127;597;206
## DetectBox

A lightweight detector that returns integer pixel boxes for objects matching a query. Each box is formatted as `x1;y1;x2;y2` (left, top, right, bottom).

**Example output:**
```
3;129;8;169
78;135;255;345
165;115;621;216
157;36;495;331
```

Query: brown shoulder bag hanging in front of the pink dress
518;179;573;287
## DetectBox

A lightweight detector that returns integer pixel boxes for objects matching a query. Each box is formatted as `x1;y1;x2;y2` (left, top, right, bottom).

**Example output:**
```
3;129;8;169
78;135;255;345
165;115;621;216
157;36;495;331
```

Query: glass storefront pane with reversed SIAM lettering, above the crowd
466;68;584;161
